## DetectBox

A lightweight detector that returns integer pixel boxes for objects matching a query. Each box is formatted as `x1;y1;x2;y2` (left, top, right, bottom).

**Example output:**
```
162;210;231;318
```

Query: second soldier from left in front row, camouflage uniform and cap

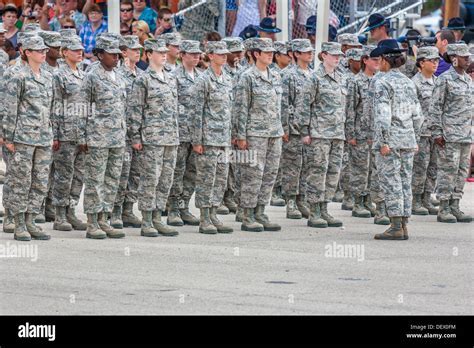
79;35;126;239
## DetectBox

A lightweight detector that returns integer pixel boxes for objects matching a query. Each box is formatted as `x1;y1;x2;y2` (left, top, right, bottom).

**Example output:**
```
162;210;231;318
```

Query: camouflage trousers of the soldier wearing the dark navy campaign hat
375;149;415;217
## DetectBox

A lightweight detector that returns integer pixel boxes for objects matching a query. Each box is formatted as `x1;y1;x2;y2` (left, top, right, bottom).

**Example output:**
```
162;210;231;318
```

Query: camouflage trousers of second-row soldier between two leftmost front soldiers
52;141;86;207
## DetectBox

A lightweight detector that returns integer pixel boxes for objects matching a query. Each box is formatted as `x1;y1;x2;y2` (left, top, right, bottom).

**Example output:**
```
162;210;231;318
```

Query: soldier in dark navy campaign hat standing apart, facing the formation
372;39;423;240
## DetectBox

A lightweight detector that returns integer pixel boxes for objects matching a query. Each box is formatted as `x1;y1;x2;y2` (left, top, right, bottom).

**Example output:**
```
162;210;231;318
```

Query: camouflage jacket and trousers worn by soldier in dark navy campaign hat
373;69;423;217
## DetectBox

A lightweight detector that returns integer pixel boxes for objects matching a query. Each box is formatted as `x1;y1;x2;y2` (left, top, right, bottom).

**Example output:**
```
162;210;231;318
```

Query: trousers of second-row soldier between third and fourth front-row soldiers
169;142;196;202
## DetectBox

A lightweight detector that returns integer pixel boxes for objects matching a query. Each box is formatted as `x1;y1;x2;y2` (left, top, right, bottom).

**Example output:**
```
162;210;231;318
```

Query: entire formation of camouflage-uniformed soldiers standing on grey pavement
0;26;473;241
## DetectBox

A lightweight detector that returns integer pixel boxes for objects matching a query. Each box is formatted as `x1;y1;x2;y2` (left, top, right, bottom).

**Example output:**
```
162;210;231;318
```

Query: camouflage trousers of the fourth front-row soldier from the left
195;146;229;208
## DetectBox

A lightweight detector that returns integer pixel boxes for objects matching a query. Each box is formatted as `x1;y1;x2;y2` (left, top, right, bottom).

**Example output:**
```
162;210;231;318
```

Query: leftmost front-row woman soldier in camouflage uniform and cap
3;36;53;241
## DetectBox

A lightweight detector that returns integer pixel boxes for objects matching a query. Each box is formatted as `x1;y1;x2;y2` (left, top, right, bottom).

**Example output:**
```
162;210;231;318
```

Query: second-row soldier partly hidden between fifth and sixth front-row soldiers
280;39;315;219
